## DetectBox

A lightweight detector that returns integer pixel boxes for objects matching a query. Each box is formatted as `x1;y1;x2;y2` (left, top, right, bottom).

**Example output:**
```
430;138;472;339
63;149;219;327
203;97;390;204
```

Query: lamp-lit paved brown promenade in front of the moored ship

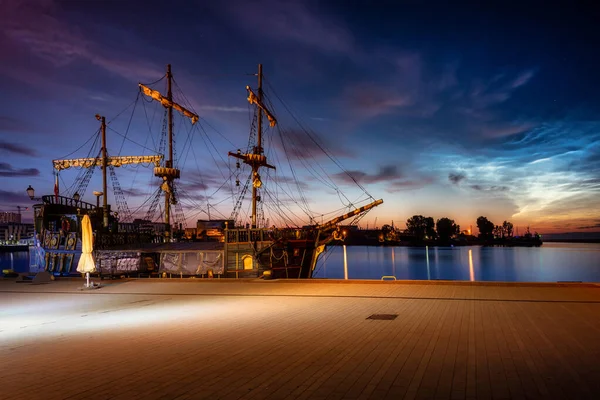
0;279;600;400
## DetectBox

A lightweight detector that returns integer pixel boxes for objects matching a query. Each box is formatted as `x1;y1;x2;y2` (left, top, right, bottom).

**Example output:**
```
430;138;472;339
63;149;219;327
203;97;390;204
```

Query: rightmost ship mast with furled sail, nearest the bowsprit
229;64;277;228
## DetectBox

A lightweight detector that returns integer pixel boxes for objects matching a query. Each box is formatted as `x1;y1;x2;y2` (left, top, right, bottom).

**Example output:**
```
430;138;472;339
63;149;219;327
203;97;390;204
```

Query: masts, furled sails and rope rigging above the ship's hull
54;66;374;234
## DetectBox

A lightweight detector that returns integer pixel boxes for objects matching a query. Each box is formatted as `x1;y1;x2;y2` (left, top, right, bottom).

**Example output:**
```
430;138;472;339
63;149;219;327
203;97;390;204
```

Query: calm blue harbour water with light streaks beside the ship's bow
315;243;600;282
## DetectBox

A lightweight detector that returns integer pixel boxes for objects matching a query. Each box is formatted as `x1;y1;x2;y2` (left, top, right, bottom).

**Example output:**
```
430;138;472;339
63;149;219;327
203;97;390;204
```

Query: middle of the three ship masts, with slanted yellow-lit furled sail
139;64;199;241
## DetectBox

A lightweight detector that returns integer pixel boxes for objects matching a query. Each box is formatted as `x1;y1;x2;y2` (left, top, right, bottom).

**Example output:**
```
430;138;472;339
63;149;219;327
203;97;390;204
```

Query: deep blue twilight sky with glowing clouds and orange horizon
0;0;600;233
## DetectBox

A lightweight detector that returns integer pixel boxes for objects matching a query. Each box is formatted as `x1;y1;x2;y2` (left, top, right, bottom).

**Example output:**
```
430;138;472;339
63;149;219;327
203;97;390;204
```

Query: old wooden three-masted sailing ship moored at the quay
28;65;383;278
